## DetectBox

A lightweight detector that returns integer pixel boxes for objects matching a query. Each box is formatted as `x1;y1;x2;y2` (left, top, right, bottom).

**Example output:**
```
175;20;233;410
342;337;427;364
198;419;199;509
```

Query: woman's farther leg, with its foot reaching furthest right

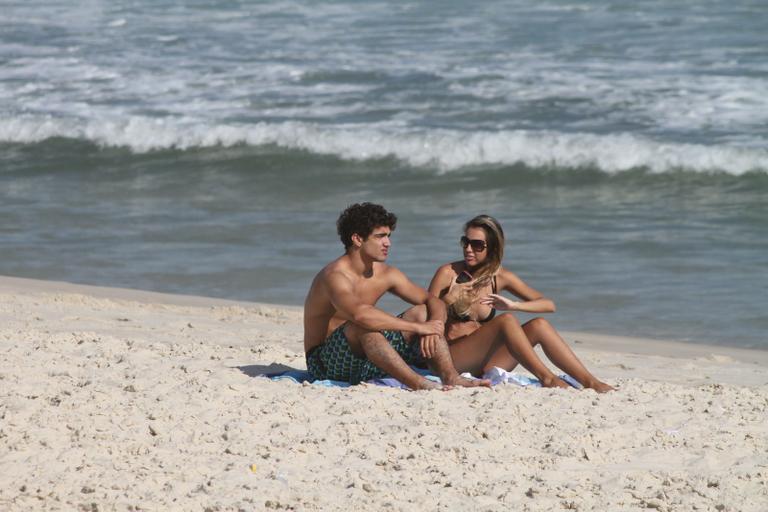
488;317;613;393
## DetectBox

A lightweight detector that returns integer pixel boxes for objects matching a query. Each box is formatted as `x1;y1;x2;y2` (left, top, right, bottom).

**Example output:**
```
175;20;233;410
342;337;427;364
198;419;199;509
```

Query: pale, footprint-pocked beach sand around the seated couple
0;278;768;512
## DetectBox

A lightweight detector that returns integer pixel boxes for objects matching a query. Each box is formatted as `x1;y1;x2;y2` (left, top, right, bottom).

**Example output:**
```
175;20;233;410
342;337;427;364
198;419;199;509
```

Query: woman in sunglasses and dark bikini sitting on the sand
429;215;613;393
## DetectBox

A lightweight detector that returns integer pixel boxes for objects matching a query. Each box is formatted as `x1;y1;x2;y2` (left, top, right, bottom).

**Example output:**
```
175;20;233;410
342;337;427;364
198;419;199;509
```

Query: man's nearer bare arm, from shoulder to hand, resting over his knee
326;272;442;335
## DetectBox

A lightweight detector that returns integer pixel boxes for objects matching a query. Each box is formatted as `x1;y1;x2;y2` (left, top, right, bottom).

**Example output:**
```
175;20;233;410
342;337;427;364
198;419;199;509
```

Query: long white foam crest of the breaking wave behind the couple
0;117;768;175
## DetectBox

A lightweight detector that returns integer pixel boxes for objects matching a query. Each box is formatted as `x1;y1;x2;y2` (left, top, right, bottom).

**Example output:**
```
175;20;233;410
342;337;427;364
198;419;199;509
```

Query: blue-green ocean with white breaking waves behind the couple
0;0;768;349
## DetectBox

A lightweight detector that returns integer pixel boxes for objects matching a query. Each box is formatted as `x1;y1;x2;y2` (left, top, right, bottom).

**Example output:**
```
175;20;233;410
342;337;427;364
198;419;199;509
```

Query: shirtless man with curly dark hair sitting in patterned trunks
304;203;489;389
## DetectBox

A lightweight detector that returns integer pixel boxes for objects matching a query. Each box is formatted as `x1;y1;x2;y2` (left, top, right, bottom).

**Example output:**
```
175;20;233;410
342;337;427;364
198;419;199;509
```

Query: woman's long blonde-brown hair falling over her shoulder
449;215;504;317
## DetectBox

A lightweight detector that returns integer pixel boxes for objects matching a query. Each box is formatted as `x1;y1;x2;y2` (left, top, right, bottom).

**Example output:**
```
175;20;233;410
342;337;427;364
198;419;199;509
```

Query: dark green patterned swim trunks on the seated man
306;323;424;384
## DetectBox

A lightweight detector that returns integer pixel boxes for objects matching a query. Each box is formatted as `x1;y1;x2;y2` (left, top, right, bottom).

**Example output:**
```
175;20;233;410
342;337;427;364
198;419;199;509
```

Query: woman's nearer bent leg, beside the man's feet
449;315;569;388
